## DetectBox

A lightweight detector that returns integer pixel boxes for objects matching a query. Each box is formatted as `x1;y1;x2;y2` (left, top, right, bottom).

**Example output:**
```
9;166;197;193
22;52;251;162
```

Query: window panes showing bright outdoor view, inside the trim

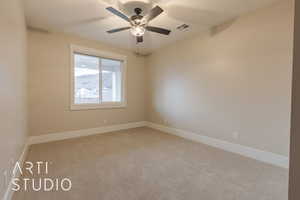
74;53;122;104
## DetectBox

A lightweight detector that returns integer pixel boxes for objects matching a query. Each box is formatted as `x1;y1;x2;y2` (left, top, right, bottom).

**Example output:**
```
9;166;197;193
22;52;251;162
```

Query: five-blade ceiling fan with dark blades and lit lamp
106;6;171;43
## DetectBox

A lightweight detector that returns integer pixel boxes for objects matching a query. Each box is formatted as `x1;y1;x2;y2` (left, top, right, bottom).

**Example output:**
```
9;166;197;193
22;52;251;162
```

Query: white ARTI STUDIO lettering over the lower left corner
12;161;72;192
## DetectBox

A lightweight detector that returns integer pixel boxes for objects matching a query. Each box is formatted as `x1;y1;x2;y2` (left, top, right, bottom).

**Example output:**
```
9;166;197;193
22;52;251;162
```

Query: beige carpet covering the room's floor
13;128;288;200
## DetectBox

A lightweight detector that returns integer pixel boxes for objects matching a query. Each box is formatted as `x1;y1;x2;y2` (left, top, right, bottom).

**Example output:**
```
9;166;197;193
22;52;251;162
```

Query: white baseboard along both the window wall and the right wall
22;121;289;168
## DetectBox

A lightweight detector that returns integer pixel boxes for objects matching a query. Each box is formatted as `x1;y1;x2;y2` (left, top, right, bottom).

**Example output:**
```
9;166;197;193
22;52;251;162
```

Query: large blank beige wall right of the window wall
147;0;294;155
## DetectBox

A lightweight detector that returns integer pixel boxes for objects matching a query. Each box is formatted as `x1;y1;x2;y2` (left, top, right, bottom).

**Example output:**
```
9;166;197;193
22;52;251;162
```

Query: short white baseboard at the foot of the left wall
3;144;28;200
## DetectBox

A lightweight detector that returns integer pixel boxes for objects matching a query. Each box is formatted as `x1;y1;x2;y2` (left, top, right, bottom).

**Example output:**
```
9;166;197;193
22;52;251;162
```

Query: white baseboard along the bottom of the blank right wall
147;122;289;168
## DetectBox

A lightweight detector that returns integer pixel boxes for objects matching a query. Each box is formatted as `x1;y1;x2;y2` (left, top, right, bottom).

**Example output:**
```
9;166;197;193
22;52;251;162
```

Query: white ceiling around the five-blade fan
25;0;278;53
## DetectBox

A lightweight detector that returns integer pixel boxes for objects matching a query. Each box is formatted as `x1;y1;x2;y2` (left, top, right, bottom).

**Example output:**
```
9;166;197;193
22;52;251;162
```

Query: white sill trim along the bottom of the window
71;103;127;111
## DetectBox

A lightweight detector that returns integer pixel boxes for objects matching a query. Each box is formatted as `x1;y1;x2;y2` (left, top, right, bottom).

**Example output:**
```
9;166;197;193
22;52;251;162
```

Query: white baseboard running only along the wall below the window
28;121;147;145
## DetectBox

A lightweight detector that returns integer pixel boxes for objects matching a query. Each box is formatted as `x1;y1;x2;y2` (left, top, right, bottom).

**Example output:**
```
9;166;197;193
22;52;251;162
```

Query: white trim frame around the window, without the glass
70;44;127;110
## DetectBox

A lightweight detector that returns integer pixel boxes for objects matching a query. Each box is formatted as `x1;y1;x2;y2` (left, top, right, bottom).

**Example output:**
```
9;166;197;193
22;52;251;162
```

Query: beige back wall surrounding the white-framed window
28;31;145;135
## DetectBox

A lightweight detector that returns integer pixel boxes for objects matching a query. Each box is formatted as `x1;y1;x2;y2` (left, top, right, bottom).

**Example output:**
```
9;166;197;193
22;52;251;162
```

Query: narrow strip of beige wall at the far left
0;0;27;198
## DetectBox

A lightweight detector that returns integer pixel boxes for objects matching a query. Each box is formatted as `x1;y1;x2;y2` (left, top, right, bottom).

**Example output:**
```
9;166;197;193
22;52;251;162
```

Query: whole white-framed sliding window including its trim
71;46;126;110
